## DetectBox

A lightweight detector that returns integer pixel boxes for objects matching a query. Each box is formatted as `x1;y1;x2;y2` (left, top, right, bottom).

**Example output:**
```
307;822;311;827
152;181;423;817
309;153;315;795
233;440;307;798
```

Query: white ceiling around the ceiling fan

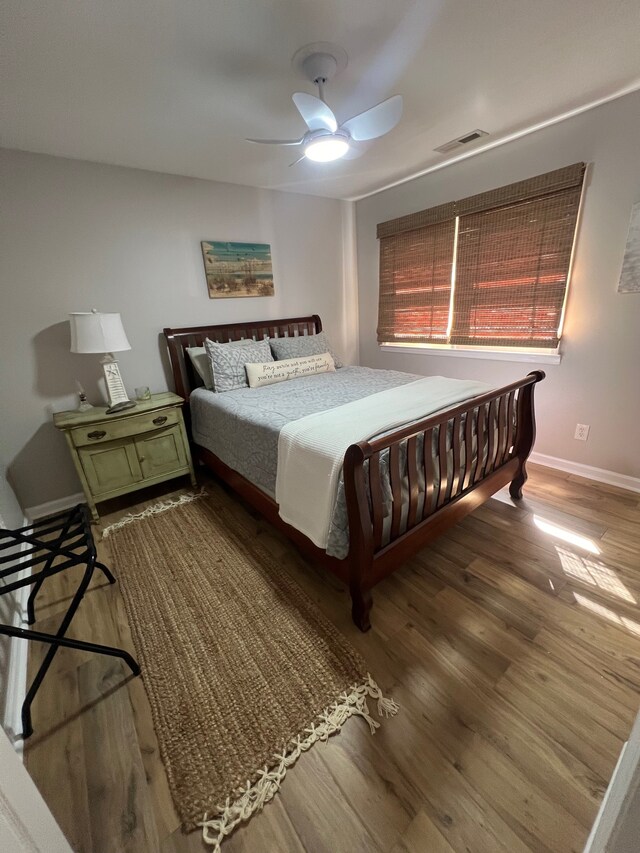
0;0;640;198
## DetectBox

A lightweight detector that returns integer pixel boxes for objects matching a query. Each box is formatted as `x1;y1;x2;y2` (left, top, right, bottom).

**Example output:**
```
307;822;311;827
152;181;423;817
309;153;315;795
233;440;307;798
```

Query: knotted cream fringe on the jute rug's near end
198;673;399;853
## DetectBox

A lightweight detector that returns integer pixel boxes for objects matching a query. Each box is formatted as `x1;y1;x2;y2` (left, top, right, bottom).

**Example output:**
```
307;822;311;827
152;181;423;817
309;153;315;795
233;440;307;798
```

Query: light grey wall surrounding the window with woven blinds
356;93;640;477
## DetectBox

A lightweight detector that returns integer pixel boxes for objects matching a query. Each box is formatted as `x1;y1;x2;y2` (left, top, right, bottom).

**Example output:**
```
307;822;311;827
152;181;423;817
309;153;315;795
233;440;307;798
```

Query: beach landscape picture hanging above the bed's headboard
202;240;273;299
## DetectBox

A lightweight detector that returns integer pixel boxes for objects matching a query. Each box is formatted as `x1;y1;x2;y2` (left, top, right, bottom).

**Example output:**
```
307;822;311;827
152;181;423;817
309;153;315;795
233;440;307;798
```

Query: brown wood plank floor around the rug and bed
26;466;640;853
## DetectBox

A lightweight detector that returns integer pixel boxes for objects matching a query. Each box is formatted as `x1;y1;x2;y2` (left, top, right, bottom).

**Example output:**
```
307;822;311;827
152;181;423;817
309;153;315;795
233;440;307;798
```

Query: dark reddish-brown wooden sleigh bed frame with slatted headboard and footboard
164;315;545;631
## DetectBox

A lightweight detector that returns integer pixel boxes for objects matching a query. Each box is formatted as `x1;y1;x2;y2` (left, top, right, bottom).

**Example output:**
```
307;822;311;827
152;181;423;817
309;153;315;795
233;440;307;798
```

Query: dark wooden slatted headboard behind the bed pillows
163;314;322;400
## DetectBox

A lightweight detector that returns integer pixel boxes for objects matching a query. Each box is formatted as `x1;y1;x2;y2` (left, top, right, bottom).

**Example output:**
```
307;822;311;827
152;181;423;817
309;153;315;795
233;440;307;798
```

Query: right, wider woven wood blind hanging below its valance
450;186;581;348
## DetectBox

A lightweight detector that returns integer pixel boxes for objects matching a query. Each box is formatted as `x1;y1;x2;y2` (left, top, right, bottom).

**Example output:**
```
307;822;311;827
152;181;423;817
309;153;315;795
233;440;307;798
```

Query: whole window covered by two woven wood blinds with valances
378;163;585;349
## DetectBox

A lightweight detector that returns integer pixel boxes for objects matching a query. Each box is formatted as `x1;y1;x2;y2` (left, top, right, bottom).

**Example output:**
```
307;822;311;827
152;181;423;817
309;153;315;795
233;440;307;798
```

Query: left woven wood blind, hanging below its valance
378;219;455;343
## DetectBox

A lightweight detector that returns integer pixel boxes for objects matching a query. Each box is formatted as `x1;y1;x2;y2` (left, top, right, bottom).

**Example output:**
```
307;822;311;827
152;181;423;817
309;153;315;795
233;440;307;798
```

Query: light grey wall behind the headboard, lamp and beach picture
0;150;357;506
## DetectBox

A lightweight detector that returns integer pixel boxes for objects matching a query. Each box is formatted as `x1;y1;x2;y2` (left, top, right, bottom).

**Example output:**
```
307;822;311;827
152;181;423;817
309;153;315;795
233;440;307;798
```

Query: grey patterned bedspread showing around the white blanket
189;367;423;559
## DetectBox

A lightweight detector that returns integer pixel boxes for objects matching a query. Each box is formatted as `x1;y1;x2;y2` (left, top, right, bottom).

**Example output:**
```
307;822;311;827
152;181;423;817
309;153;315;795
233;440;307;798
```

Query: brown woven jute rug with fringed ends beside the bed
103;495;397;850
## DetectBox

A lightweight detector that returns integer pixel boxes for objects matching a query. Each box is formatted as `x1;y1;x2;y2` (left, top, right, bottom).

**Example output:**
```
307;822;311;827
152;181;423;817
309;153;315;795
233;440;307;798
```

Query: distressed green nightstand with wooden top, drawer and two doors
53;391;196;521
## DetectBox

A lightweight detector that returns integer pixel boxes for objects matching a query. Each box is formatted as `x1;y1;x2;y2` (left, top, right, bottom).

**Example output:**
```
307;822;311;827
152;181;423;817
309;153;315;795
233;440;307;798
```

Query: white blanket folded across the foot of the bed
276;376;491;549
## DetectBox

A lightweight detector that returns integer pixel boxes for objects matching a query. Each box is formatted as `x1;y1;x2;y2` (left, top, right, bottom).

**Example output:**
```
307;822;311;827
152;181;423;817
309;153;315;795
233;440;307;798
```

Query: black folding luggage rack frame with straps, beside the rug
0;504;140;738
